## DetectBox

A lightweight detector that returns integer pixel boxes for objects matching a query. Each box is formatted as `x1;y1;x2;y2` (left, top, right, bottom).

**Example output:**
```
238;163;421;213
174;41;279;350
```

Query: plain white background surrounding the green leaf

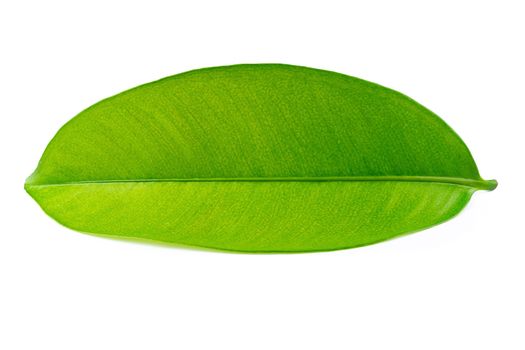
0;0;525;350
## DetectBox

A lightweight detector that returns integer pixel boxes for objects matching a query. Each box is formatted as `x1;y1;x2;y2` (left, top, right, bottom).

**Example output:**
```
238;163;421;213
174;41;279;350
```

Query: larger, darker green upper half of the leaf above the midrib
24;64;492;185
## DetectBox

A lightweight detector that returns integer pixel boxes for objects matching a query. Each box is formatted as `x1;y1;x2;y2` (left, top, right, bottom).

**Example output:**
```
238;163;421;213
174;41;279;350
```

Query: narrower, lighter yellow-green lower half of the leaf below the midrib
26;181;475;252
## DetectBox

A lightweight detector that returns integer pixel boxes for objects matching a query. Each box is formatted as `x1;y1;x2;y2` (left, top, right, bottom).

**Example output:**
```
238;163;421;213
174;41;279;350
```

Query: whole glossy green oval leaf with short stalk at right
25;64;496;252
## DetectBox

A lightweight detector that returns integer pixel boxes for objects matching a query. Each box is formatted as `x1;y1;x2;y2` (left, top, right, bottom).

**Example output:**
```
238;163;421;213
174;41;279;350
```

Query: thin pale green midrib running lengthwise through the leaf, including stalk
26;176;498;191
